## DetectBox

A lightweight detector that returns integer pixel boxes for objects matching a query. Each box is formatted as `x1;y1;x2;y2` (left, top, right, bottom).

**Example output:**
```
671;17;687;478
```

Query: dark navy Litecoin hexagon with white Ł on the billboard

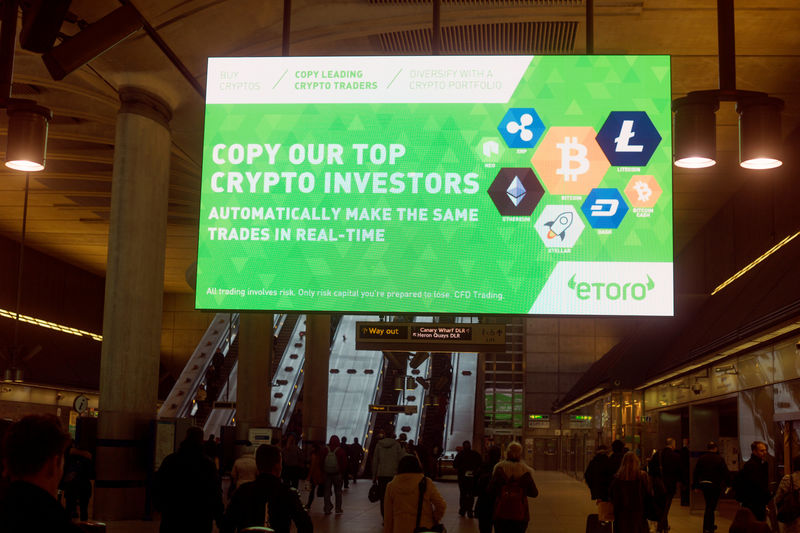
597;111;661;167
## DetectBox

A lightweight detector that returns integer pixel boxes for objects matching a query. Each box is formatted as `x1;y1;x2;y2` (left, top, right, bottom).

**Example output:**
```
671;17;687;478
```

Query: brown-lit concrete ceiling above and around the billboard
0;0;800;292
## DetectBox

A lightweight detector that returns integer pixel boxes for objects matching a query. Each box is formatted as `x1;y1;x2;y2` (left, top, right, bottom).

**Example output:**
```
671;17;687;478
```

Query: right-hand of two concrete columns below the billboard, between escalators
303;315;331;442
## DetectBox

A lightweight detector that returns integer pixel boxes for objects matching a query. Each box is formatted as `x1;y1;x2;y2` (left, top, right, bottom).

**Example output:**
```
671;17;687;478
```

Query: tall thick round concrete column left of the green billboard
94;88;171;520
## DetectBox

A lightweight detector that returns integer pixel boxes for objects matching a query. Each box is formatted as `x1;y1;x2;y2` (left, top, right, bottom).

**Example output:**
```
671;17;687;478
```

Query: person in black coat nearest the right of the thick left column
153;427;224;533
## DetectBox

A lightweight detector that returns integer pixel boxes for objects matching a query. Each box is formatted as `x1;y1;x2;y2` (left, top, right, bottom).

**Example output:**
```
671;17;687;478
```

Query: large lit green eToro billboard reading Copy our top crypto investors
196;56;673;315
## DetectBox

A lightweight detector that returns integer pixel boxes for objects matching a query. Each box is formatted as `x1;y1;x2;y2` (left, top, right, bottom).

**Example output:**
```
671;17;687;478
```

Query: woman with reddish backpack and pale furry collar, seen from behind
488;441;539;533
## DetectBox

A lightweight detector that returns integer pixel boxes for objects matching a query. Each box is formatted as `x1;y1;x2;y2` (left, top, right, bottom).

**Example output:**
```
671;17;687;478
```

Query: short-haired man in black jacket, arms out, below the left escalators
220;444;314;533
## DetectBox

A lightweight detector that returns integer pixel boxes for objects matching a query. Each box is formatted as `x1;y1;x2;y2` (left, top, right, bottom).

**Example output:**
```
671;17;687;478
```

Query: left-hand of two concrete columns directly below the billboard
236;313;273;440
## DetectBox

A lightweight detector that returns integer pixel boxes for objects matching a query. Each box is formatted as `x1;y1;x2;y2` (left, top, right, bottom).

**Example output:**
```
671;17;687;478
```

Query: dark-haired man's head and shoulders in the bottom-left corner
0;415;81;533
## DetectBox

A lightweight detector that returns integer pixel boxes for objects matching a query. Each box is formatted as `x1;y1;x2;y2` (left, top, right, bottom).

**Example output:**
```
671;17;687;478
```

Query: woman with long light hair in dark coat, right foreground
608;452;651;533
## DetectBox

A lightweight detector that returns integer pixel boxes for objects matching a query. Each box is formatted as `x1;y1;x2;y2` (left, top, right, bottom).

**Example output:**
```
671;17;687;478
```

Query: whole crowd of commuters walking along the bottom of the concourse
0;415;800;533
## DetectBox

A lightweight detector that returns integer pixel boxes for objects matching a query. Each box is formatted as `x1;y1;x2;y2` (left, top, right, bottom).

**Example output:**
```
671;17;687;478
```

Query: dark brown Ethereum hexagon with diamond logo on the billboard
486;168;544;217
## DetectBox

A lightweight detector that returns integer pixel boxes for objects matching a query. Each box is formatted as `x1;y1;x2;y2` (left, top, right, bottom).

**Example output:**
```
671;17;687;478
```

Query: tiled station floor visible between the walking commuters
103;472;735;533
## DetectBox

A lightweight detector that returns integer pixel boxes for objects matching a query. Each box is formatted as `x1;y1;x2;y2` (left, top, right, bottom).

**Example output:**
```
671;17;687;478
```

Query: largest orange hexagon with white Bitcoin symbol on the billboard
531;126;611;195
